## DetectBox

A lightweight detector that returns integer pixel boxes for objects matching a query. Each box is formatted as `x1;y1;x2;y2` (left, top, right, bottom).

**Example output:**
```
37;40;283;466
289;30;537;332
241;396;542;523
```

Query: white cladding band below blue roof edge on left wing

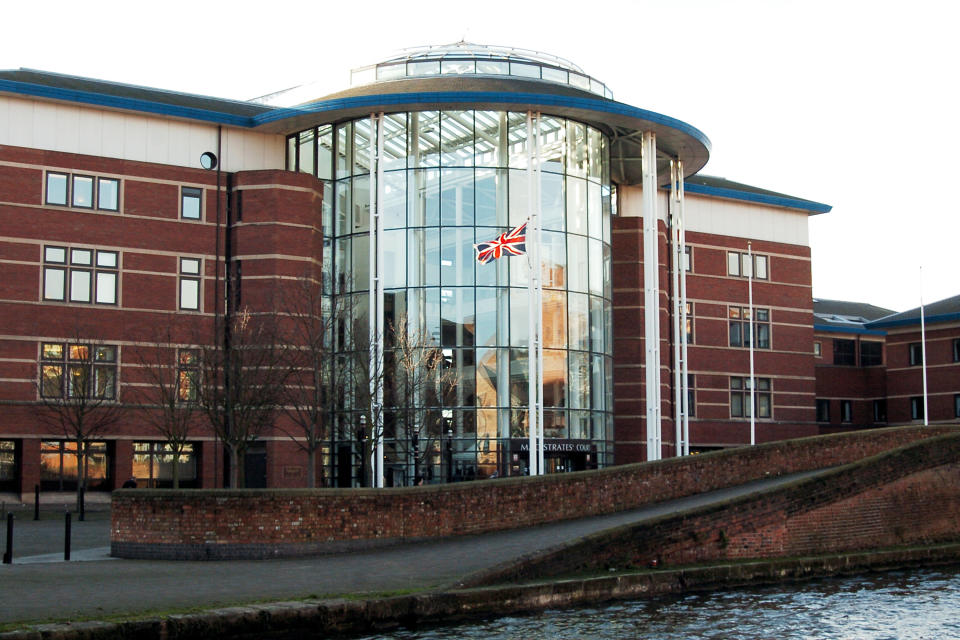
0;96;285;171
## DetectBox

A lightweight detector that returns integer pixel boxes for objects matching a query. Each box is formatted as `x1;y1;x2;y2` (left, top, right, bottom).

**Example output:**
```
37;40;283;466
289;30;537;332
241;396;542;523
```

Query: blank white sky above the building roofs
0;0;960;311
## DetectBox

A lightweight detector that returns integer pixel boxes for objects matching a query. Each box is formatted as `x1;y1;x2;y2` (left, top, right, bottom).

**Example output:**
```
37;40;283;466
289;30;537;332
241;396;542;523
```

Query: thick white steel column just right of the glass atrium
642;131;661;460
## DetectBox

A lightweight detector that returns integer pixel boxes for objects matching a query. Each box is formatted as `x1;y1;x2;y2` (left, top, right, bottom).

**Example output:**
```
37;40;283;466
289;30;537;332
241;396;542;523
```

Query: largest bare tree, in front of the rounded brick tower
197;309;288;487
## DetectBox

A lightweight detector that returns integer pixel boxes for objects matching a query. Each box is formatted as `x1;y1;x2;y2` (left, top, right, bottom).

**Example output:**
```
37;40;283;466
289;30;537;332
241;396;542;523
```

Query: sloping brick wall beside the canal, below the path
464;433;960;586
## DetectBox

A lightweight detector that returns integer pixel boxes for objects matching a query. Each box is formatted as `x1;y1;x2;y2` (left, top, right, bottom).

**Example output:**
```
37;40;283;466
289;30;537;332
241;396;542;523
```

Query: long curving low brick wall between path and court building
111;427;958;560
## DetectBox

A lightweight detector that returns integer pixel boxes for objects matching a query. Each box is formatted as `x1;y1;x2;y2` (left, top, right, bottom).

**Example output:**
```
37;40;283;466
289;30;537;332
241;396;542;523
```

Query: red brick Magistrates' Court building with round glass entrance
0;52;830;494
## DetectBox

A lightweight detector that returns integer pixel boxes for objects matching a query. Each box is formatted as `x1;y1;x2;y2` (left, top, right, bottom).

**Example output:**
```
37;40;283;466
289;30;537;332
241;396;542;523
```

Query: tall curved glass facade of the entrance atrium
288;111;613;486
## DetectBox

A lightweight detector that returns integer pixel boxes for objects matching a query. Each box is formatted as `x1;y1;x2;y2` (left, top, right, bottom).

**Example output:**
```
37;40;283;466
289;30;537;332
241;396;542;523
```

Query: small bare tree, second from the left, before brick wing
136;324;202;489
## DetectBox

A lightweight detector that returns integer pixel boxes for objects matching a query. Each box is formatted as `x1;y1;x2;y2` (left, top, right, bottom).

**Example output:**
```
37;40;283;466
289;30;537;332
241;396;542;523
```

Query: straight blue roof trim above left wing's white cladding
0;79;255;128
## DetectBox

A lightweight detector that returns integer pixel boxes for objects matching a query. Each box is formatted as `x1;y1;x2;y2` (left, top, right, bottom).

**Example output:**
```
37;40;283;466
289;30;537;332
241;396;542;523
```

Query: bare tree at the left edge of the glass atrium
280;275;338;488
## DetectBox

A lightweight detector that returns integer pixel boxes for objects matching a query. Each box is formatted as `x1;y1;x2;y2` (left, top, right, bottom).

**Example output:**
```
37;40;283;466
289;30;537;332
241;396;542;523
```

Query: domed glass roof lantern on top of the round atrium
350;42;613;100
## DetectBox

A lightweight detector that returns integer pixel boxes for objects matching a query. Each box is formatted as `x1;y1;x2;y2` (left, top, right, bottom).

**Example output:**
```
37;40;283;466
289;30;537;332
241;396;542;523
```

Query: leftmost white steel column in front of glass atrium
361;113;384;487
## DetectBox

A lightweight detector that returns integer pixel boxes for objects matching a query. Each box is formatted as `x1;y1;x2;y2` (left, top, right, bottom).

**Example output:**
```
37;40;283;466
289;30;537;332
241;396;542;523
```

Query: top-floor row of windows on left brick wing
44;171;203;220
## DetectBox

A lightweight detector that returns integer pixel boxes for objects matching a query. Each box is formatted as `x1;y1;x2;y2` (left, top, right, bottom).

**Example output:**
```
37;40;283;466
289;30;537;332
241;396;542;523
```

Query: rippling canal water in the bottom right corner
358;567;960;640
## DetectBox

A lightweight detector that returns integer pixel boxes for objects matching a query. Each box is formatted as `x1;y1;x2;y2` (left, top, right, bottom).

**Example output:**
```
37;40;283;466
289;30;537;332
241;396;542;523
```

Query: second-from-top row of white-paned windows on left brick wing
43;246;202;311
